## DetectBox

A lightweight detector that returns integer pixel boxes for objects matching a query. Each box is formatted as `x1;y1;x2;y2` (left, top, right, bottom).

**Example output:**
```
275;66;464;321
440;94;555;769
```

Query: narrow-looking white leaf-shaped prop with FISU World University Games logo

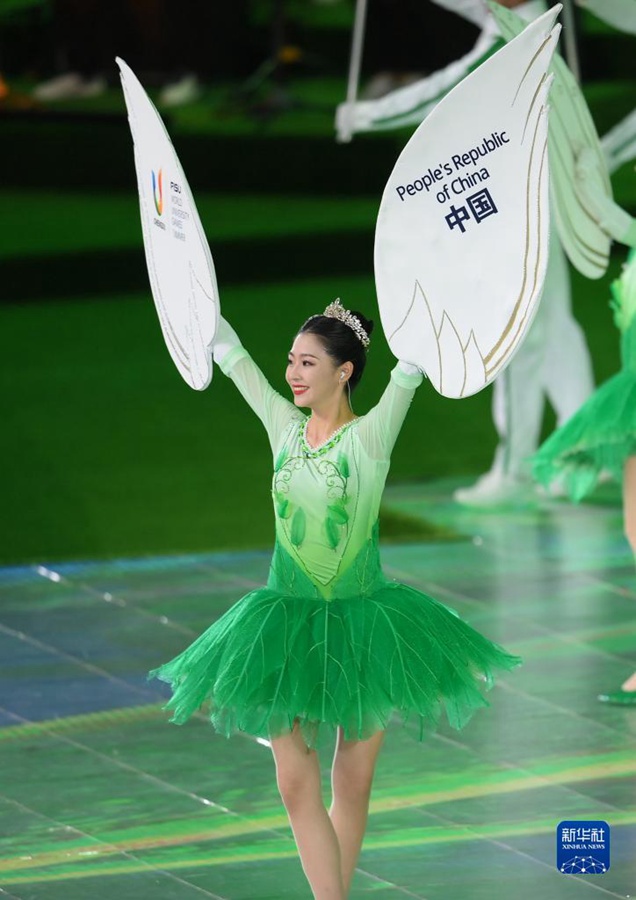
117;59;220;391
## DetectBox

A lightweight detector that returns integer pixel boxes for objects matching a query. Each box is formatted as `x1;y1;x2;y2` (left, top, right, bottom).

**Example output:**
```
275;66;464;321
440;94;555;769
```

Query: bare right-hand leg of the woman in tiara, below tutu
329;729;384;897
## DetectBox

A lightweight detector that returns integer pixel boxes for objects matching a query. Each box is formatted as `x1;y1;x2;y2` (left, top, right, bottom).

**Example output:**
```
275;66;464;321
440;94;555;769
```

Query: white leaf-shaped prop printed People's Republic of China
375;7;560;397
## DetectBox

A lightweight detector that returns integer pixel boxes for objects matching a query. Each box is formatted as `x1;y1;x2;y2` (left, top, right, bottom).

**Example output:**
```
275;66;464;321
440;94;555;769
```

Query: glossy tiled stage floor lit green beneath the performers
0;482;636;900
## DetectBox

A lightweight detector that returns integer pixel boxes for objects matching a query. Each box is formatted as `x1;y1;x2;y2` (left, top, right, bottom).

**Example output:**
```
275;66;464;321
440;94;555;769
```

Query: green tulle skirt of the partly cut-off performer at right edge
533;369;636;500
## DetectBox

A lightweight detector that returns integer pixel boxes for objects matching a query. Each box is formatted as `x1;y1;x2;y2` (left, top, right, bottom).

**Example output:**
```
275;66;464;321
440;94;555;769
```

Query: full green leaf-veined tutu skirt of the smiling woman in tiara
149;537;520;746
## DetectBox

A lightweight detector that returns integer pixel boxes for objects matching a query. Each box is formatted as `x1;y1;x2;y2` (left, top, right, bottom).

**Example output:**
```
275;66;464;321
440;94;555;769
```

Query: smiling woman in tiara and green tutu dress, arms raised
151;300;519;900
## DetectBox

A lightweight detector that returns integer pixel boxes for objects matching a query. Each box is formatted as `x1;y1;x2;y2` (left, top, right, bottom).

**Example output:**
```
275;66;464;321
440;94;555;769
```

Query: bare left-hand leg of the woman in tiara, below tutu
272;726;346;900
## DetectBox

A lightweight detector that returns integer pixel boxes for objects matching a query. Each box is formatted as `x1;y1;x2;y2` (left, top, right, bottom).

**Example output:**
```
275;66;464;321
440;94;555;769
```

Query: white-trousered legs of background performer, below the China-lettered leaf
454;230;594;506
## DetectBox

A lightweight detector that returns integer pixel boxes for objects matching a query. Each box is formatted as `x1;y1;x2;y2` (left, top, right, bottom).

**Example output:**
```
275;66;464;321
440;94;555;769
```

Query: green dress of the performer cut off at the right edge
533;251;636;500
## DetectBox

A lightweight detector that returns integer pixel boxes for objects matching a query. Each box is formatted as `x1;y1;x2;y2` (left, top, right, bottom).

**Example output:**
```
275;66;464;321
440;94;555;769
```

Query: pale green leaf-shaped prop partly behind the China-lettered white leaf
489;3;618;278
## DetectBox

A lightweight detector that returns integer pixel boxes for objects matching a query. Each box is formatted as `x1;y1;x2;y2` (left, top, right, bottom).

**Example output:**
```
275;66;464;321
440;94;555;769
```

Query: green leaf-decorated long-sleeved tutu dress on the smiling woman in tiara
150;347;520;746
